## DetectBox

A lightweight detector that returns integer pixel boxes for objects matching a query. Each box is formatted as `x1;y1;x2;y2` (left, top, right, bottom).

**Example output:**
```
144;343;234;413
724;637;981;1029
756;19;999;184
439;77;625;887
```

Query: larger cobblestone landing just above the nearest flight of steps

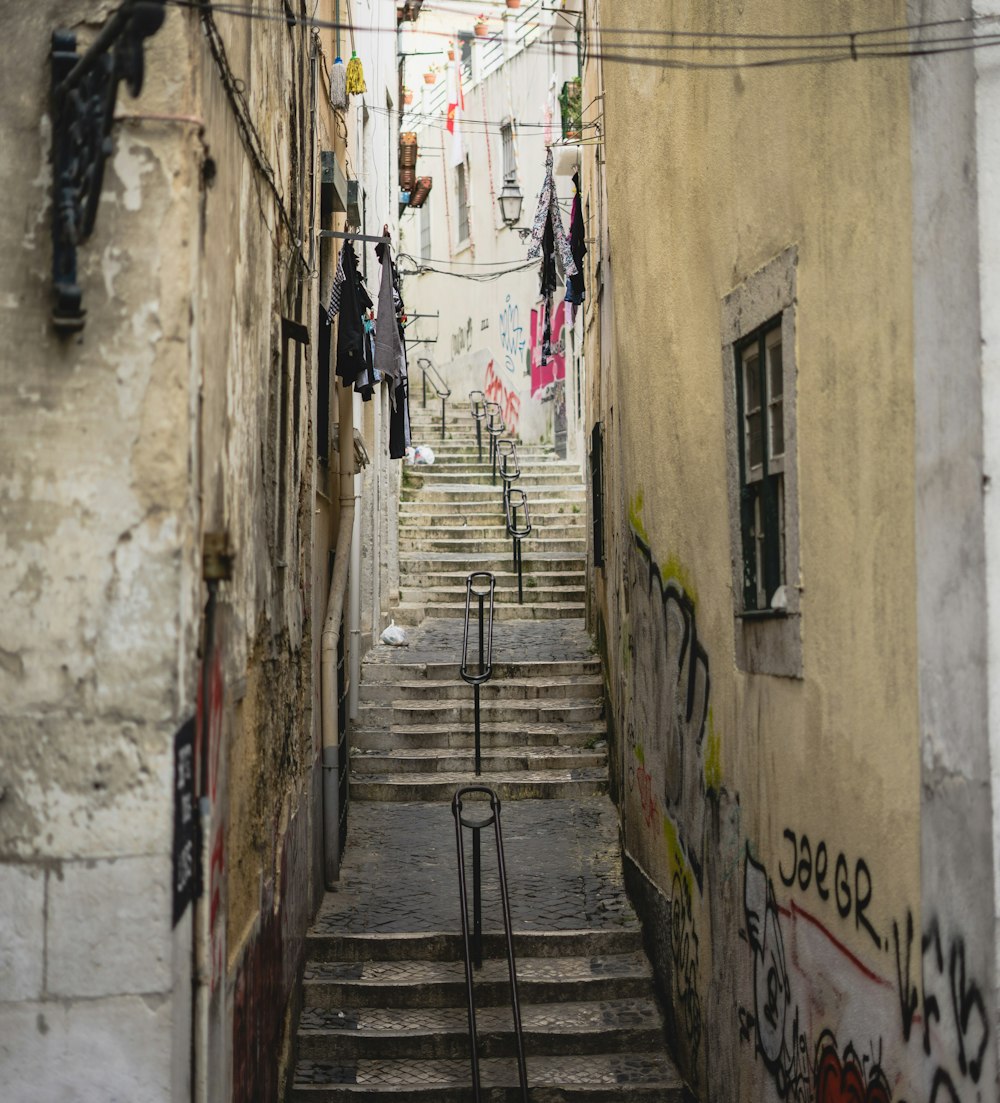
313;796;637;934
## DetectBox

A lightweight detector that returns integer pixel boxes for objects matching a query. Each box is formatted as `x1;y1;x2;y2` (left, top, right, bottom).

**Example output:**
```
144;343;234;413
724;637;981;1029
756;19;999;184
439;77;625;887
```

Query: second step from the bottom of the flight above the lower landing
351;739;607;778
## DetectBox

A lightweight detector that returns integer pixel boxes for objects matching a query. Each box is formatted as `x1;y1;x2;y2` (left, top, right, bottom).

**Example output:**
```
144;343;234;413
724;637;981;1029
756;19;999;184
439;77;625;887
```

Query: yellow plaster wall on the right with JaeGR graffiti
595;0;996;1103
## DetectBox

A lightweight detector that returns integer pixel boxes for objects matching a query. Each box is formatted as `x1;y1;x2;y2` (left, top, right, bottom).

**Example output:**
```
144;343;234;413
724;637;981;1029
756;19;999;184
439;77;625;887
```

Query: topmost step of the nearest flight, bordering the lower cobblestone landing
305;930;643;962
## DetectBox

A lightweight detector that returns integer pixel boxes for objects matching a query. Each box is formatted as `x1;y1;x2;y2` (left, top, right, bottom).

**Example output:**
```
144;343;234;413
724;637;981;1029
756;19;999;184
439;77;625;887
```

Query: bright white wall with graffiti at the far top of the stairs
401;4;582;441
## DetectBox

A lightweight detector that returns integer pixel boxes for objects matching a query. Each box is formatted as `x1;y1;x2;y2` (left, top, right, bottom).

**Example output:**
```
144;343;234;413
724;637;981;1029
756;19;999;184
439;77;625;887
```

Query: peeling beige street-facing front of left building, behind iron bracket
0;2;201;1101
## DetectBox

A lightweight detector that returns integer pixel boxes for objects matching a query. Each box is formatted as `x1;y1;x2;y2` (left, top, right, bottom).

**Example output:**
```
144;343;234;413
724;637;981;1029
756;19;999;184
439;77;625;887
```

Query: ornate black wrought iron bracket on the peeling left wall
50;0;166;334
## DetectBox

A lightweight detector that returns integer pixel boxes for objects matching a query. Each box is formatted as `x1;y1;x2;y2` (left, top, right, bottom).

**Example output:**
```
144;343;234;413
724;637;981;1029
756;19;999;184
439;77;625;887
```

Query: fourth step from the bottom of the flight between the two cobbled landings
357;686;604;729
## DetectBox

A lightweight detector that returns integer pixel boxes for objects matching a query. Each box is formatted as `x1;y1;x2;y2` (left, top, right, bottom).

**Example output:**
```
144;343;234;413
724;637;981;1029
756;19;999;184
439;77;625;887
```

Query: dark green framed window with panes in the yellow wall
734;317;786;614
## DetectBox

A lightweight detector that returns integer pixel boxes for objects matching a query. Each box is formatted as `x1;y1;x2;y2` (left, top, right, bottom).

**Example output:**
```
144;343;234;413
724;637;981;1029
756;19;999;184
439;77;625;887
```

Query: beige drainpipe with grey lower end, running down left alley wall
320;387;355;888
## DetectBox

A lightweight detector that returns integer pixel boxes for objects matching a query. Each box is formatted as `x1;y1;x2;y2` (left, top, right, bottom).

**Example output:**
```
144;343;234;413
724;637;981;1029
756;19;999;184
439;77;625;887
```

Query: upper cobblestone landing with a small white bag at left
365;618;595;663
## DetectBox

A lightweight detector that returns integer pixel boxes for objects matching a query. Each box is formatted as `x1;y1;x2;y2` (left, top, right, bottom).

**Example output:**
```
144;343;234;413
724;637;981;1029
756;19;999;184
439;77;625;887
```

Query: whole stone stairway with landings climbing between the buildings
284;406;684;1103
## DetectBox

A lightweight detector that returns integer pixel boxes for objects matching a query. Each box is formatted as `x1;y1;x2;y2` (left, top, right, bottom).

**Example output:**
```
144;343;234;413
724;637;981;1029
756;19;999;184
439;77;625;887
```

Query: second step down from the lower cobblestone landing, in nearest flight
303;953;653;1009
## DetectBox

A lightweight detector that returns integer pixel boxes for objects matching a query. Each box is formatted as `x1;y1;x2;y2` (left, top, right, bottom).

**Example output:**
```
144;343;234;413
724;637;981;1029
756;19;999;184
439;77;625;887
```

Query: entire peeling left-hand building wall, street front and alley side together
0;0;395;1103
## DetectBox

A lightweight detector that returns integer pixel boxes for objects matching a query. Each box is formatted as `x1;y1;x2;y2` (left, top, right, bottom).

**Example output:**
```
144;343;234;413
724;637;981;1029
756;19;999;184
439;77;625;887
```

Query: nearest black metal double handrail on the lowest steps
451;785;528;1103
